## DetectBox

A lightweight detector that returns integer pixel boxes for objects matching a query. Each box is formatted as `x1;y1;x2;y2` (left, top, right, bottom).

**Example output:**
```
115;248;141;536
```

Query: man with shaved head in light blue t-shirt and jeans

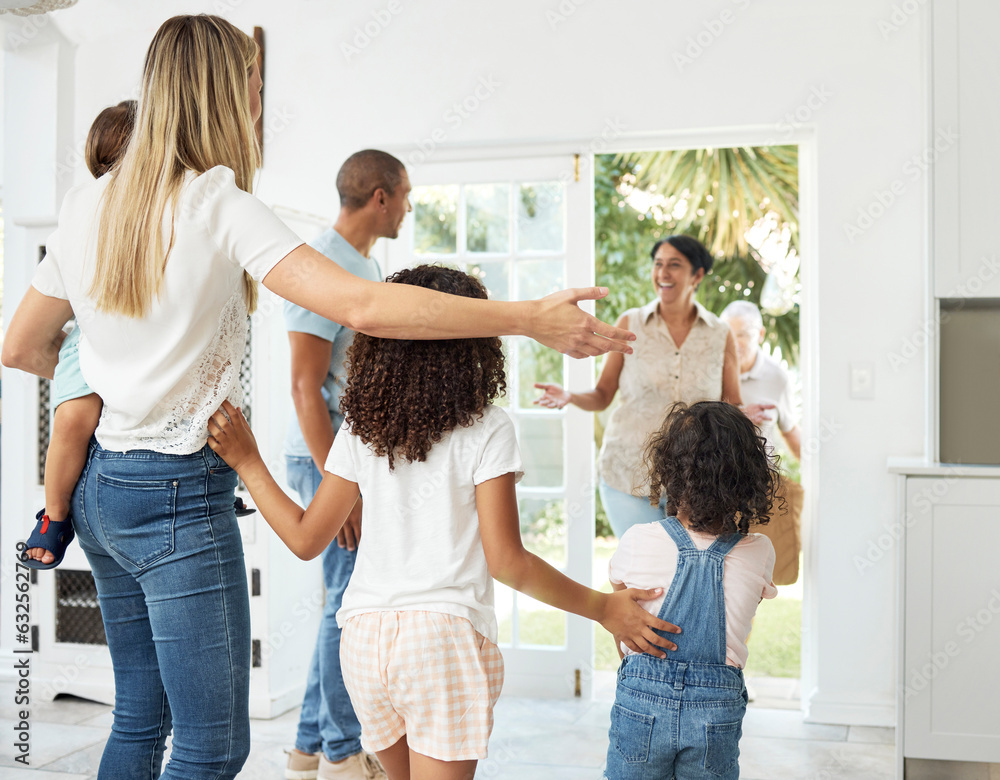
285;149;411;780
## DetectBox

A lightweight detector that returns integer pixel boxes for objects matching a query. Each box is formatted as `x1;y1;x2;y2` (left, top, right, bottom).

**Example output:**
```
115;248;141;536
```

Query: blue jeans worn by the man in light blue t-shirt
285;455;361;761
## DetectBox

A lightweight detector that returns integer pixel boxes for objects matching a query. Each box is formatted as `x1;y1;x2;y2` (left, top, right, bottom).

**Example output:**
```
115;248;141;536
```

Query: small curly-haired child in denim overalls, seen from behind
605;401;777;780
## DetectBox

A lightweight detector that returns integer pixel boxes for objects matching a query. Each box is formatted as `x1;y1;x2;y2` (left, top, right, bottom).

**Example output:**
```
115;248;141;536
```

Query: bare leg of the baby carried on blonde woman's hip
27;393;104;563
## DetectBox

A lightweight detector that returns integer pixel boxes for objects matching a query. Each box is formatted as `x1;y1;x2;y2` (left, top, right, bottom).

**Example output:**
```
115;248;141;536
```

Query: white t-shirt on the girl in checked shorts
326;406;524;643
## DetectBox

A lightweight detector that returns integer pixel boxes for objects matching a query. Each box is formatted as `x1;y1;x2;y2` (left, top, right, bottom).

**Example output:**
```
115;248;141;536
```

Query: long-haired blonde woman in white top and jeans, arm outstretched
3;16;631;779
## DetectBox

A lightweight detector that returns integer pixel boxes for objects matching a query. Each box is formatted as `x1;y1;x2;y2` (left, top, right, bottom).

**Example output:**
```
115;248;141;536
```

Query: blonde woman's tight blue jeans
73;440;250;780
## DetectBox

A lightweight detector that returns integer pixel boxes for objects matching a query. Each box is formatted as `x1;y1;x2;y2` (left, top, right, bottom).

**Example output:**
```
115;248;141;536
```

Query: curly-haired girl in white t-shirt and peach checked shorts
209;266;679;780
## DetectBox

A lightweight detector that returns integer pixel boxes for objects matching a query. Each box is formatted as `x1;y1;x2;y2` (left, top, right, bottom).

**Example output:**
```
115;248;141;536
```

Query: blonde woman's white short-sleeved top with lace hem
32;166;302;455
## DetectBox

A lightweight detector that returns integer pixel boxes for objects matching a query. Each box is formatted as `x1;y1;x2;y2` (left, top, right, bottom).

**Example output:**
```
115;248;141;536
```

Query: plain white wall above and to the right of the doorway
7;0;929;723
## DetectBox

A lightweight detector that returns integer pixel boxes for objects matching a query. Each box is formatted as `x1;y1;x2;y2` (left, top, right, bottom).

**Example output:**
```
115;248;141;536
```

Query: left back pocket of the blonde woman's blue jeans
97;474;177;569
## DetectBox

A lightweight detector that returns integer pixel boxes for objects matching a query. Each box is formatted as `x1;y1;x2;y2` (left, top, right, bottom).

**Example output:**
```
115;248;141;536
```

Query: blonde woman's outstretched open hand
527;287;635;358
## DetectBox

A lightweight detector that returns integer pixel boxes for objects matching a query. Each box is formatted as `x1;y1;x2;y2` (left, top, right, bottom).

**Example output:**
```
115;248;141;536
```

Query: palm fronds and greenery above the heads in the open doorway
595;146;799;364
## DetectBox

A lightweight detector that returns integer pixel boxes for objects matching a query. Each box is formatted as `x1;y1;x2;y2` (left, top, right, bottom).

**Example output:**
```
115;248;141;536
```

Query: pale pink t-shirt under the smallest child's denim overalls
608;523;778;669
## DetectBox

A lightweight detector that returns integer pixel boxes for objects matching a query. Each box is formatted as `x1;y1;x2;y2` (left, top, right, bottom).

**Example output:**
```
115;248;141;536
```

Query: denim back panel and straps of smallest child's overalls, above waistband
658;517;740;664
